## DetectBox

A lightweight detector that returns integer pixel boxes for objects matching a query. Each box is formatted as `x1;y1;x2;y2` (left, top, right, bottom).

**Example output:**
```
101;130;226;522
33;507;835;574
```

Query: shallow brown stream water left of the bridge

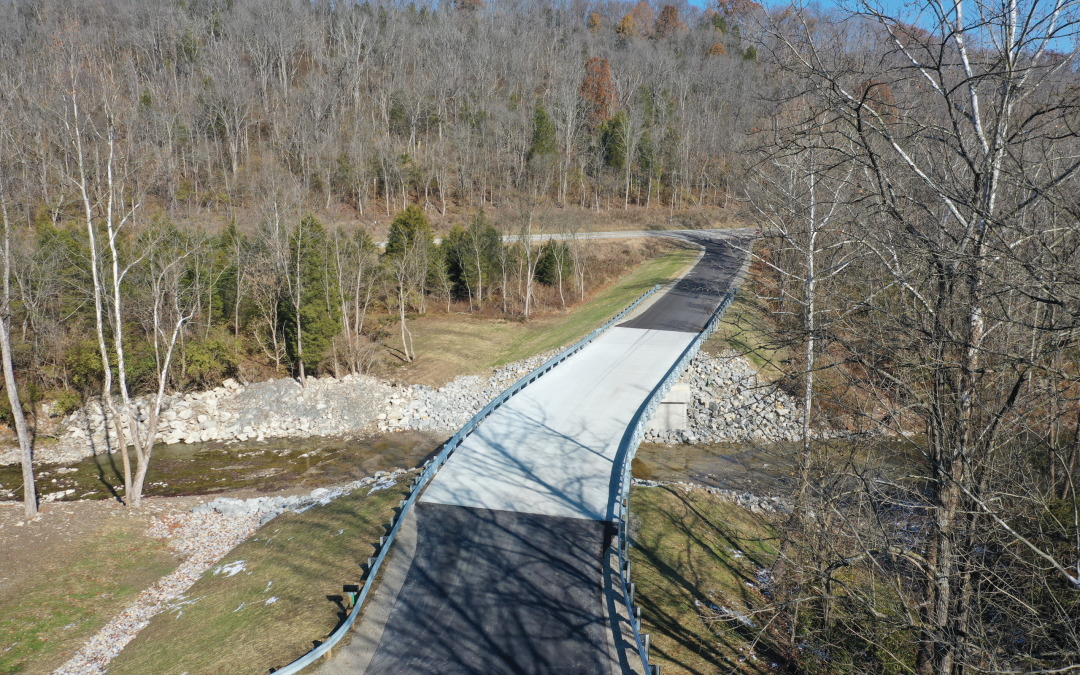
0;432;447;500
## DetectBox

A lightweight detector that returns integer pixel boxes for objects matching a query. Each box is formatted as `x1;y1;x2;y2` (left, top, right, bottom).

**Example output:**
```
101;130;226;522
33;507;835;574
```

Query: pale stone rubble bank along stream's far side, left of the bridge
0;350;559;464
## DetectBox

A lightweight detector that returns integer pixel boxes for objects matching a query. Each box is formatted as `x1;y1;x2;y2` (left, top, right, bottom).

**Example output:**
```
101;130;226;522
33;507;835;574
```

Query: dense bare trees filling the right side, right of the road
744;0;1080;675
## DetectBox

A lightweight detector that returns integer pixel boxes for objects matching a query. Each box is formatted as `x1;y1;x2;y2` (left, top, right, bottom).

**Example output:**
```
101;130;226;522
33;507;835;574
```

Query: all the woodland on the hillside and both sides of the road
0;0;1080;675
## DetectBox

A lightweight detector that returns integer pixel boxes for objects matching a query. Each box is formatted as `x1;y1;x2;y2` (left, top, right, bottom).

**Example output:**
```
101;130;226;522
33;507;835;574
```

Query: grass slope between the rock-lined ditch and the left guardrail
109;474;413;675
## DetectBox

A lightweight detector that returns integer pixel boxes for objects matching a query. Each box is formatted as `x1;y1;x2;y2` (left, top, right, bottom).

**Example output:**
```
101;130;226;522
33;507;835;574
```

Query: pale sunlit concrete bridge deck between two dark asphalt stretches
421;327;694;521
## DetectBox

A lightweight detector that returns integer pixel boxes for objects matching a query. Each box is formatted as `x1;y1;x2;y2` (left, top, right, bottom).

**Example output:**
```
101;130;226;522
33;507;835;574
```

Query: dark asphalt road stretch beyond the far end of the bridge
619;234;752;333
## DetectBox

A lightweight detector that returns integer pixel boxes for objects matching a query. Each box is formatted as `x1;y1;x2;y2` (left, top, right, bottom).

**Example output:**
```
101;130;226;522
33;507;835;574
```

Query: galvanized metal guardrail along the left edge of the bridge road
274;284;660;675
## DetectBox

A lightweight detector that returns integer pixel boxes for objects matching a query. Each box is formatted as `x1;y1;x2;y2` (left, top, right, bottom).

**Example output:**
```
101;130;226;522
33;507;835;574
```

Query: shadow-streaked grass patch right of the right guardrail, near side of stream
631;486;783;675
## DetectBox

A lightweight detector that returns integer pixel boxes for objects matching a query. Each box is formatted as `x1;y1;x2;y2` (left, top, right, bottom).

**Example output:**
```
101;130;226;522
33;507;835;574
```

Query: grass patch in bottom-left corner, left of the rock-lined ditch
0;518;178;675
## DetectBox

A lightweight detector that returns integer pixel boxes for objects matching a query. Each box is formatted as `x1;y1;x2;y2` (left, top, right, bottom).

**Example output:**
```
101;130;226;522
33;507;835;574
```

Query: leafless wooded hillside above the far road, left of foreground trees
0;0;758;221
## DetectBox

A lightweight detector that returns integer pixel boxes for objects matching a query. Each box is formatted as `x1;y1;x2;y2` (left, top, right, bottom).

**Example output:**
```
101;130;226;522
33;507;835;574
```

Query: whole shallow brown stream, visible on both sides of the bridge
0;431;909;500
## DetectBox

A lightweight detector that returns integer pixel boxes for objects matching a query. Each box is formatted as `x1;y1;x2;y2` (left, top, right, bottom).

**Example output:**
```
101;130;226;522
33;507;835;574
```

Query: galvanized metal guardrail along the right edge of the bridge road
613;291;735;675
